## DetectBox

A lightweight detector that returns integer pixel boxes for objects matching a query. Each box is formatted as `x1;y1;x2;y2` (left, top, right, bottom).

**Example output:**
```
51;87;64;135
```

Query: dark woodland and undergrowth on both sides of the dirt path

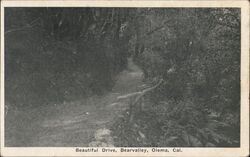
5;8;241;147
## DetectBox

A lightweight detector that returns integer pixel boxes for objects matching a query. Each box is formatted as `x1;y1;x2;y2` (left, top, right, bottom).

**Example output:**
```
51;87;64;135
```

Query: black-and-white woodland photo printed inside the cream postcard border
1;0;249;155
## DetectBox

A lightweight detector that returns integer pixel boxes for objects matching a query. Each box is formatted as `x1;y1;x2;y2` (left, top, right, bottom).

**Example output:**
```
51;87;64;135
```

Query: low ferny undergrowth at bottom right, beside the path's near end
113;100;239;147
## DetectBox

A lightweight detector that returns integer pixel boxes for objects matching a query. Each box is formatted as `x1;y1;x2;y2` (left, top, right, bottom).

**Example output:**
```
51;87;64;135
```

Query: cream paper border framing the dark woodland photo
0;0;249;156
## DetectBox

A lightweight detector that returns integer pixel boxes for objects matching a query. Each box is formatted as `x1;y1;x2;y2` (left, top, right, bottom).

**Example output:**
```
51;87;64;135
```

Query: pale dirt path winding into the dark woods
5;59;142;147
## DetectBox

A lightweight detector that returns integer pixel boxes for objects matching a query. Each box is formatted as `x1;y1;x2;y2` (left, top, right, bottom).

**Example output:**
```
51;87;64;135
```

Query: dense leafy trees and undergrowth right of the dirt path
111;9;240;146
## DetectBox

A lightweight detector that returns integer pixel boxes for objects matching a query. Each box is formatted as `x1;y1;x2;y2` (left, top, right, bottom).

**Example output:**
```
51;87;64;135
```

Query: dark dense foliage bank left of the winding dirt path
5;8;129;105
